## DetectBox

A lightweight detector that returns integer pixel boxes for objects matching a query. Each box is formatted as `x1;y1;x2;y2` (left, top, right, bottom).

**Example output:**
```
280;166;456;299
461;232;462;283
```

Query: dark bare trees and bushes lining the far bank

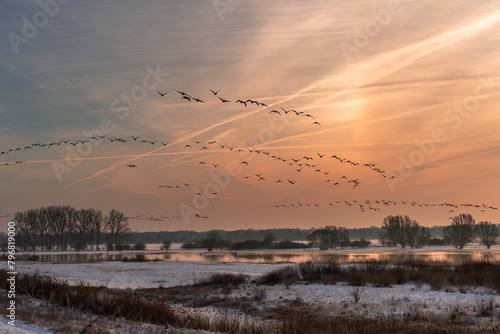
5;205;500;251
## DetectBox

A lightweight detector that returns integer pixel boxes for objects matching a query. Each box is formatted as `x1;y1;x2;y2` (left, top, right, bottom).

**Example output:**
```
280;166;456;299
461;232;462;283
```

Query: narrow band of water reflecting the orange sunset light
18;250;500;265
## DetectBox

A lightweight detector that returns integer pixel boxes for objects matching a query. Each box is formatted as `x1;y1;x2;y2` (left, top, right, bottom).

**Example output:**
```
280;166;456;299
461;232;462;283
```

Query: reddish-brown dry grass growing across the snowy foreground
0;264;500;334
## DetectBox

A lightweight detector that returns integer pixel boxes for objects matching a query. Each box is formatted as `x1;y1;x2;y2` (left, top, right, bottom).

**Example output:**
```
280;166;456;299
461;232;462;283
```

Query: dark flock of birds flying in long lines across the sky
0;89;497;221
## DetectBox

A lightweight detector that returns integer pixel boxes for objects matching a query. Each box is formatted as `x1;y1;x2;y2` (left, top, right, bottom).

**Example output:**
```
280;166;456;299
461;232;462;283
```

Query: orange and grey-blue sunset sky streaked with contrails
0;0;500;231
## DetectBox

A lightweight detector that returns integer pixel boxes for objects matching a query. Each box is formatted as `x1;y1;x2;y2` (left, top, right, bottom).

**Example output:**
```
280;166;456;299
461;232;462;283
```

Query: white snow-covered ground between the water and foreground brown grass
17;261;500;316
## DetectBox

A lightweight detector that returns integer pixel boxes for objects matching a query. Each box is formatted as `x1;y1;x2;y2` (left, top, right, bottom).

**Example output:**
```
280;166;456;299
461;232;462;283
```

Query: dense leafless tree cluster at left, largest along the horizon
14;205;130;251
